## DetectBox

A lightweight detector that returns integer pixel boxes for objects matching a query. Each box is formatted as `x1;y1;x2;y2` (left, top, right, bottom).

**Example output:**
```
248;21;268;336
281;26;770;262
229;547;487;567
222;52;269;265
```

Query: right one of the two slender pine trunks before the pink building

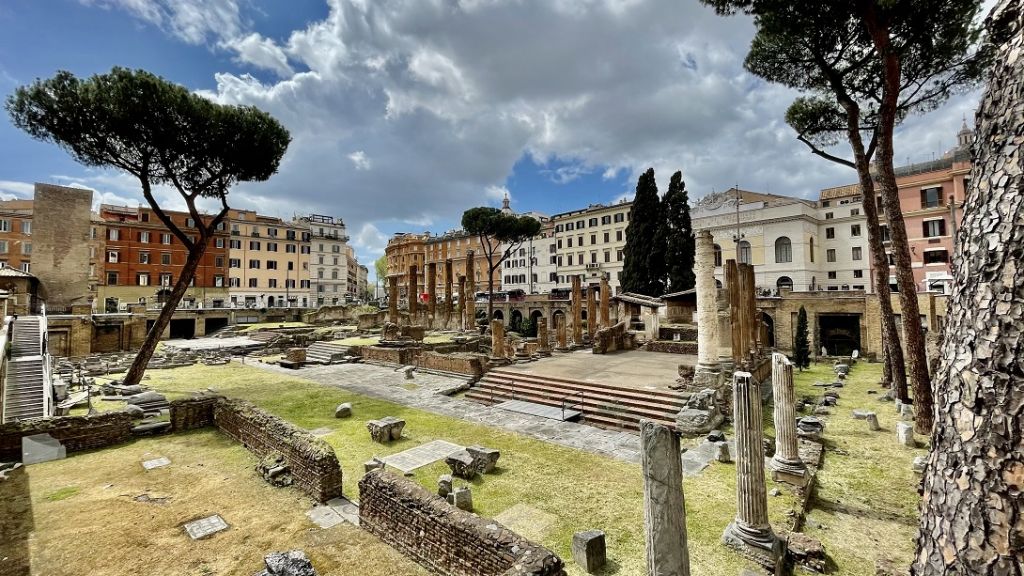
864;7;935;436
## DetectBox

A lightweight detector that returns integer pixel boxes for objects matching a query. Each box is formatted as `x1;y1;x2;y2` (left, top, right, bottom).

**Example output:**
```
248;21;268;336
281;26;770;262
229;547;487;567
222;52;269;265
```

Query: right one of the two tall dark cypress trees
662;172;696;292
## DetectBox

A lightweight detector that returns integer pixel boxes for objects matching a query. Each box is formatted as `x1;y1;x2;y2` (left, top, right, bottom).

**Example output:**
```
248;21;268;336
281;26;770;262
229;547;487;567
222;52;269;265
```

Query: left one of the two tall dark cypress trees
622;168;666;296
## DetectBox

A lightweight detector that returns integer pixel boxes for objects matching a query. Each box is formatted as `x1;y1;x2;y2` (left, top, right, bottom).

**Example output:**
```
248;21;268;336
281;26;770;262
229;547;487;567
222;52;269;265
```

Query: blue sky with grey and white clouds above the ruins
0;0;978;276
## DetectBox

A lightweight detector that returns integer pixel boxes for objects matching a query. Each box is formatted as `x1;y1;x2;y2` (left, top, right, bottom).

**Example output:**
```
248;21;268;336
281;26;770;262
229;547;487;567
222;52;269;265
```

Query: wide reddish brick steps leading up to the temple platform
466;369;689;430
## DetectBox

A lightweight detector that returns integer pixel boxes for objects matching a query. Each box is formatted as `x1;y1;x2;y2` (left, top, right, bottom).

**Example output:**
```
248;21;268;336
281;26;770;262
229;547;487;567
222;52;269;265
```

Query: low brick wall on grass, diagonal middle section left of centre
213;400;341;502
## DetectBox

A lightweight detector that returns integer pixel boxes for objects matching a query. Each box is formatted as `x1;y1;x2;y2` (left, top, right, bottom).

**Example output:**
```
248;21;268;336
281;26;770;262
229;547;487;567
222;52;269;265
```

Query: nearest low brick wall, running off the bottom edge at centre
359;469;565;576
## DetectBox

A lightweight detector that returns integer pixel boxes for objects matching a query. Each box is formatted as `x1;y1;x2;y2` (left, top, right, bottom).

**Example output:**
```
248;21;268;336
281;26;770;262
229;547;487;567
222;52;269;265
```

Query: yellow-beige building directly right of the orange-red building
227;210;314;307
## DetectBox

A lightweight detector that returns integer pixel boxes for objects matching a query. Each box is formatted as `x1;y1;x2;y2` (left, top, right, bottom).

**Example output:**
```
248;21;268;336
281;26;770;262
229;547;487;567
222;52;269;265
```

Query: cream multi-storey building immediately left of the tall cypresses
547;201;633;294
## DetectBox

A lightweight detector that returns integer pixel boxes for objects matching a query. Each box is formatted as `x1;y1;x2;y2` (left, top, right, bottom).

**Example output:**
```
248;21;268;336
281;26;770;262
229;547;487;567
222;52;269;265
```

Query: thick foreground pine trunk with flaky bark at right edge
912;0;1024;576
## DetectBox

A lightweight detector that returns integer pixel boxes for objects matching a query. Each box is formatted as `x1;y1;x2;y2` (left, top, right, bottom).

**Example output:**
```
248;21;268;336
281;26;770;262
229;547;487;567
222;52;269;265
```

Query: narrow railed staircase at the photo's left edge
3;316;51;422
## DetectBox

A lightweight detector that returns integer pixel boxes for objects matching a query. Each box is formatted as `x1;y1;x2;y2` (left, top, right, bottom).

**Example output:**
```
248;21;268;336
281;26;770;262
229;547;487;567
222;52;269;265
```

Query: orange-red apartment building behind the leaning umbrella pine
92;204;228;313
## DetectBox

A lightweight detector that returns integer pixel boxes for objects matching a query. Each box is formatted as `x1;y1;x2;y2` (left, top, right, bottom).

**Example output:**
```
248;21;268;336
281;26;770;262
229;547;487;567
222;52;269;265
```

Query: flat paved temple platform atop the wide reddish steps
502;349;697;390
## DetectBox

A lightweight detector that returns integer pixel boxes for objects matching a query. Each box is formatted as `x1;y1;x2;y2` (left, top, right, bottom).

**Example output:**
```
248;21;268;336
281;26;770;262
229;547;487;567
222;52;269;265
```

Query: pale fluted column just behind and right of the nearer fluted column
769;352;807;486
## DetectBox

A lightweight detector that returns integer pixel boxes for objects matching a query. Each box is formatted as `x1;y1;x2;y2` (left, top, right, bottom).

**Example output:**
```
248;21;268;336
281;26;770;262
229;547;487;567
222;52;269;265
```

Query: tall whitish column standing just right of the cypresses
693;230;721;386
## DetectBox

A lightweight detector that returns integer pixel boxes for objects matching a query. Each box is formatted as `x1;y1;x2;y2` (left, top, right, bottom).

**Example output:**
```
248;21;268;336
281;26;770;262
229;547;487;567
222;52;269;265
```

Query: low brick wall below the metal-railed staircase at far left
0;411;132;461
